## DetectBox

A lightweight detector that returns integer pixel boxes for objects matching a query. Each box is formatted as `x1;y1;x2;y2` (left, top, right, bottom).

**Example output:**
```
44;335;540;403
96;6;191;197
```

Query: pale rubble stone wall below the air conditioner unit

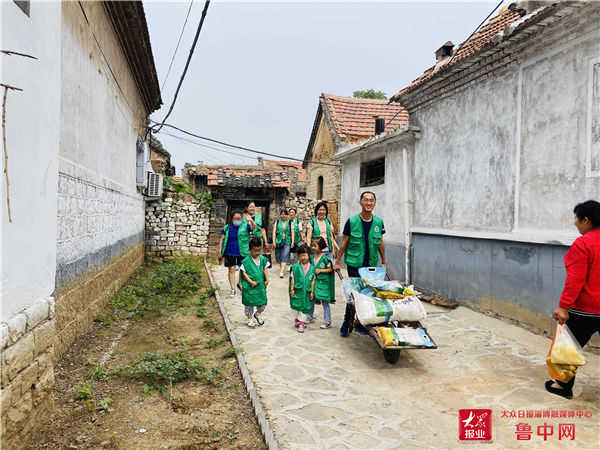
146;198;211;261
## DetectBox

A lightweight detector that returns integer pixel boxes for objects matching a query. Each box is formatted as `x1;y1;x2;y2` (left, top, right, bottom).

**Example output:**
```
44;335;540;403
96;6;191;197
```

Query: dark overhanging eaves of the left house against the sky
102;1;162;115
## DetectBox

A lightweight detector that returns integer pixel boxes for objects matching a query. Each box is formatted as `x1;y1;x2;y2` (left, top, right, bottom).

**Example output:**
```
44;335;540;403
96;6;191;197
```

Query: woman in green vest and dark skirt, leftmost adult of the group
218;211;256;297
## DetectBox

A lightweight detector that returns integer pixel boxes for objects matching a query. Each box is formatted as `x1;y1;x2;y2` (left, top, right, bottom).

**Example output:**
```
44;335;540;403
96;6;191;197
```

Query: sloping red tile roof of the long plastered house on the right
390;8;524;101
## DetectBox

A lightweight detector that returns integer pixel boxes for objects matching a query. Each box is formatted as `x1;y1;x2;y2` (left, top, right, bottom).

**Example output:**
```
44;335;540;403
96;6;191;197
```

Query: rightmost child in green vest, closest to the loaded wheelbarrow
306;236;335;329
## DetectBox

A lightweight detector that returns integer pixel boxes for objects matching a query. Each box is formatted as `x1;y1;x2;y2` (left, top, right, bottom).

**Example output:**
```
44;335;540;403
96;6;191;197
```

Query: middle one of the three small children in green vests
290;244;315;333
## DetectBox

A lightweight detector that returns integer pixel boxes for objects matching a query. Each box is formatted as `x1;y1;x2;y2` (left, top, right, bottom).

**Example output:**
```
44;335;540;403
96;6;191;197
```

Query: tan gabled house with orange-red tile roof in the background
302;94;408;230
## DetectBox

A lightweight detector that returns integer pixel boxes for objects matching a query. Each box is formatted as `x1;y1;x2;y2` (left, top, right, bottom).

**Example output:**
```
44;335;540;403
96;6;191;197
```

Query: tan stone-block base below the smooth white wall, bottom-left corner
0;297;55;448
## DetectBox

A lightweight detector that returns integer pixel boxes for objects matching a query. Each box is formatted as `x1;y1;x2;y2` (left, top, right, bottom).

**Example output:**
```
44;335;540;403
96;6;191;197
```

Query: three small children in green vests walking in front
240;236;335;333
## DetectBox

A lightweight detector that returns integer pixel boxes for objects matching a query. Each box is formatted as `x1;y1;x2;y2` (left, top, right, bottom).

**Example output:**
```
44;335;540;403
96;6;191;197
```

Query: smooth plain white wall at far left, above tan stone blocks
0;1;61;320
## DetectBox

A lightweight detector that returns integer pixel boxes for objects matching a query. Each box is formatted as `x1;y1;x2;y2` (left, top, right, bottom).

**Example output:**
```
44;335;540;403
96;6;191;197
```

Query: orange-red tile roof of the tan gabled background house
321;94;408;140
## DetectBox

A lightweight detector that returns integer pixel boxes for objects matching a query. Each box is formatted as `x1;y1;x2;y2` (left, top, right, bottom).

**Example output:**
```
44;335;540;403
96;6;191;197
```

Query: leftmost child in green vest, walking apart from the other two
240;236;270;328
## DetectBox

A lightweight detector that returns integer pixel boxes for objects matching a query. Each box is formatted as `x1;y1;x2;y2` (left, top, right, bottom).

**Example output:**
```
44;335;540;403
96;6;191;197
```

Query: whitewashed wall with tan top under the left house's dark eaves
57;2;146;281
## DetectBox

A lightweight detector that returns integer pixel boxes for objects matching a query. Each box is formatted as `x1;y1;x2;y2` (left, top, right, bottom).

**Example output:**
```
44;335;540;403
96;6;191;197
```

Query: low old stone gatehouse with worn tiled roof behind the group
182;158;314;256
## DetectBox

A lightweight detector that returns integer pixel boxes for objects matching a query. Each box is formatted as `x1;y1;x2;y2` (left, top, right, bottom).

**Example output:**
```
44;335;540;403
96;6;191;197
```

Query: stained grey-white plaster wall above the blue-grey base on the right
411;25;600;238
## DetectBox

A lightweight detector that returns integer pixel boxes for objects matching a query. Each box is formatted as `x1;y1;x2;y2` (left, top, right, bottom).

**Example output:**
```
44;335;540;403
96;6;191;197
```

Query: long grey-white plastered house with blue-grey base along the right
335;2;600;342
